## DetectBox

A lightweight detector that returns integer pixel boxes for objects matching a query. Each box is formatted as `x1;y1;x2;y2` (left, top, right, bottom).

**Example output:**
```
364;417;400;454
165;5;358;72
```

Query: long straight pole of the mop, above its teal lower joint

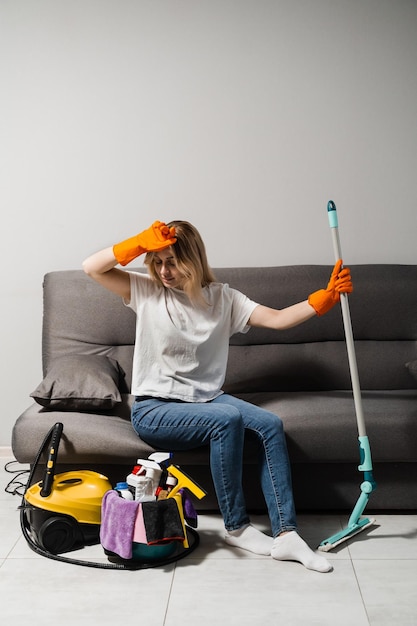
327;200;367;436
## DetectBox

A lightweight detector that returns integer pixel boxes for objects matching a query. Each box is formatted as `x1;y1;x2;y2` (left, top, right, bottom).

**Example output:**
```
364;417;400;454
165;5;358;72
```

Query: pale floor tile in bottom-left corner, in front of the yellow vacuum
0;558;174;626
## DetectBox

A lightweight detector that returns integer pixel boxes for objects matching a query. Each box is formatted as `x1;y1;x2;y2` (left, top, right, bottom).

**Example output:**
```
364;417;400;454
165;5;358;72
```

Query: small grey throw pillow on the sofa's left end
30;354;124;412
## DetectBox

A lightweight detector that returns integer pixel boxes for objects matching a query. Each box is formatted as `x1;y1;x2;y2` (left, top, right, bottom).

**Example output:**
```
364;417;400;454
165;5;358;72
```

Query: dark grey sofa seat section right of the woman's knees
238;389;417;460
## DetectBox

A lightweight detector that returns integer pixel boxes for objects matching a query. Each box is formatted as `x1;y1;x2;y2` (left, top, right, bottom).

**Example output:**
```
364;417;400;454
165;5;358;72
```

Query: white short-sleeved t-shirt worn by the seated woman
127;272;257;402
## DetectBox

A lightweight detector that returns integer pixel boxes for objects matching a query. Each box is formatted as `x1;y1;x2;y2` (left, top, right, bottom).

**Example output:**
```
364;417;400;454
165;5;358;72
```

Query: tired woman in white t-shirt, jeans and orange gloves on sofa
83;221;352;572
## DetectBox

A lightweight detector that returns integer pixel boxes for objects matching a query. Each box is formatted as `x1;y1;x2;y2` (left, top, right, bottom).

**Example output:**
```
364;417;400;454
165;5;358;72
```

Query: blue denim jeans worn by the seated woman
132;394;296;537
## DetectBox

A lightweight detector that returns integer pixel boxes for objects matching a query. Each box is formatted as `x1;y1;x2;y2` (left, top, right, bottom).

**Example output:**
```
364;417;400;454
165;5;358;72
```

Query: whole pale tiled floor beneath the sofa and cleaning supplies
0;457;417;626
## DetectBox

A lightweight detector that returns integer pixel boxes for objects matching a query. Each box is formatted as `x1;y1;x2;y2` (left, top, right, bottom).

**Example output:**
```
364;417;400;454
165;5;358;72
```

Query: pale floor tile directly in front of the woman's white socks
166;559;368;626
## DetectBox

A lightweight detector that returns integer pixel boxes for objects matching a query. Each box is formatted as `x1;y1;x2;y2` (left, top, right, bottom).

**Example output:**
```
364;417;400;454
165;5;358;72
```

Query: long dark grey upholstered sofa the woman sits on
12;265;417;510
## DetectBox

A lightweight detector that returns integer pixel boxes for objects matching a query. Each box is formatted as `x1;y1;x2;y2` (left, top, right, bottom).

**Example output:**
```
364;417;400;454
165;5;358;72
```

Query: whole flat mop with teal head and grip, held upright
318;200;376;552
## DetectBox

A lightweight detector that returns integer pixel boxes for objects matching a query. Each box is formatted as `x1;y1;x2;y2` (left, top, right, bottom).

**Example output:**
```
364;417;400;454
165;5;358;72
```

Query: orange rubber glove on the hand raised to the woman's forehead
113;220;177;265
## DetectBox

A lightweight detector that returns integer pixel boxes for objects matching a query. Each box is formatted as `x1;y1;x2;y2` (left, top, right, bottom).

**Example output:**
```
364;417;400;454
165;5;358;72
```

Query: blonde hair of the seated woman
145;220;216;304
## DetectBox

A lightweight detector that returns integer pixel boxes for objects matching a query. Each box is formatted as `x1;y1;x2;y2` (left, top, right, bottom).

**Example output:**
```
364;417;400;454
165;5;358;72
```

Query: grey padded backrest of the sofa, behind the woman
42;264;417;393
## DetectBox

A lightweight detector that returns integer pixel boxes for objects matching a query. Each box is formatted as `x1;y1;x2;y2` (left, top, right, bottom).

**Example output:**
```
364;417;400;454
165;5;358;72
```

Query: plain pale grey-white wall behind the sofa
0;0;417;446
